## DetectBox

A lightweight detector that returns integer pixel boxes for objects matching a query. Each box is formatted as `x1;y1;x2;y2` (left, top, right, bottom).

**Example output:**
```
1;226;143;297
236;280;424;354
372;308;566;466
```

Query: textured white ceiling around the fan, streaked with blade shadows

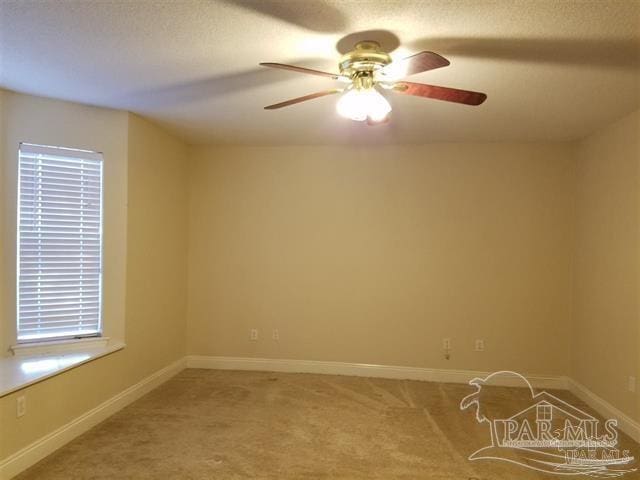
0;0;640;144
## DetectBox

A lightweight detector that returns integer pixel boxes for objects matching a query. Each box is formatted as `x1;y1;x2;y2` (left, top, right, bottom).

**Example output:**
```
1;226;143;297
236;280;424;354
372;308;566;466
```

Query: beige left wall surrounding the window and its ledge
0;94;187;459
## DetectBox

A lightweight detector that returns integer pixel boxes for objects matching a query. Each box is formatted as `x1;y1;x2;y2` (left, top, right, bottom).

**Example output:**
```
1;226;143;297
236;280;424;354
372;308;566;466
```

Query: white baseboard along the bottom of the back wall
187;355;567;390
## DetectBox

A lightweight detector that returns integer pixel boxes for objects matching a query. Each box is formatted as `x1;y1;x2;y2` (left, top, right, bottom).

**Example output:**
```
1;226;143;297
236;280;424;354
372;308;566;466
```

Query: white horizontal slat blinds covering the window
17;143;102;341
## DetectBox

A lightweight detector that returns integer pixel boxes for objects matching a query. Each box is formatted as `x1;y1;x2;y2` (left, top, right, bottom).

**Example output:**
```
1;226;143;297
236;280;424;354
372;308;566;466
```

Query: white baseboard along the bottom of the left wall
0;358;187;480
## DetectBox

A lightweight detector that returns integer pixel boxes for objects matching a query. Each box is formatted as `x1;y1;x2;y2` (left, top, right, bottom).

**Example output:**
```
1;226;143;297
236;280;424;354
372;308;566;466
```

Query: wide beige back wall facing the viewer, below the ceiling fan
187;144;574;374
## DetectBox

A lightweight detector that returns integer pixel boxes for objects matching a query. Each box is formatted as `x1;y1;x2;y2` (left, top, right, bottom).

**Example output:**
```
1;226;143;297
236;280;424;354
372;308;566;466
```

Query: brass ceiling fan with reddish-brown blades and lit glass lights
260;41;487;125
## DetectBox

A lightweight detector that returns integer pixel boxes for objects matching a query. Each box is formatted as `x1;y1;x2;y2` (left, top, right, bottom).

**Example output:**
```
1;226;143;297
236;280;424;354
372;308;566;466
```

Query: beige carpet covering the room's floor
17;369;640;480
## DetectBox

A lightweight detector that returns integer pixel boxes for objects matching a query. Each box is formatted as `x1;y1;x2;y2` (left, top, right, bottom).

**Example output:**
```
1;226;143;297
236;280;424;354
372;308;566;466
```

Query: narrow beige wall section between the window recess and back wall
126;115;188;372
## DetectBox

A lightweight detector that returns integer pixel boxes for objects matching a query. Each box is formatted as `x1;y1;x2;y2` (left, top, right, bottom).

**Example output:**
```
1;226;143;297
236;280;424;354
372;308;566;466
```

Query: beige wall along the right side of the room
569;111;640;419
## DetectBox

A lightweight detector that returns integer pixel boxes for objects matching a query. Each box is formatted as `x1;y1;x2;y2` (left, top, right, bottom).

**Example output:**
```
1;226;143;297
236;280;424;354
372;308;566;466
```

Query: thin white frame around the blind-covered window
12;142;109;344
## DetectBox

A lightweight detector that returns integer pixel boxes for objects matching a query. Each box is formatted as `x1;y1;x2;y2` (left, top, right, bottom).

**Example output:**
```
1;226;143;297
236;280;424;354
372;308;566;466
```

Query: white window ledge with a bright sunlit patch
0;338;125;397
